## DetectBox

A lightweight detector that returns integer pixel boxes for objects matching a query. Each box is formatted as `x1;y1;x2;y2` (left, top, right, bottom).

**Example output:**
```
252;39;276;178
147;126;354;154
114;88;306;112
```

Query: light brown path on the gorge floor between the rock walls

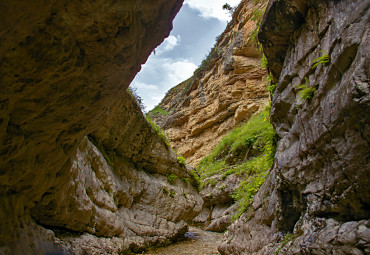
144;227;223;255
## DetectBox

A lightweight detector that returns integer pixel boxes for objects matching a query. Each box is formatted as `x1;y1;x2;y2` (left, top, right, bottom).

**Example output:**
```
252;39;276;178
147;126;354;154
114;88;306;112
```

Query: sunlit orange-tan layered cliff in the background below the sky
153;1;268;165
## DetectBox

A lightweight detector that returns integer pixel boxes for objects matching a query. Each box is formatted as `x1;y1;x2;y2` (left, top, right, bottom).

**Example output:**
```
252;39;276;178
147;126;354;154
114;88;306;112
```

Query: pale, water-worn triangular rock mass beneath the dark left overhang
31;95;203;254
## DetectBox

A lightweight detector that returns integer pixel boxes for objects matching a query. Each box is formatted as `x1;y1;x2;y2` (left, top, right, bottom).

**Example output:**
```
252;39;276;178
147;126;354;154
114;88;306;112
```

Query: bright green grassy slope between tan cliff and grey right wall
197;107;276;219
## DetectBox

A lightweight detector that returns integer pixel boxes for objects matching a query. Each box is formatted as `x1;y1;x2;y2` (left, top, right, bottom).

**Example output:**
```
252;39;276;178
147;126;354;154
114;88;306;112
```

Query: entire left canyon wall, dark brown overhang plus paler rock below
0;0;202;254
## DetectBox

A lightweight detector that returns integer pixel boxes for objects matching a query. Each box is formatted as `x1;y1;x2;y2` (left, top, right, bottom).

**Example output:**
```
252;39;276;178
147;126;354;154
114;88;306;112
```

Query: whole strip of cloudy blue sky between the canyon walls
130;0;241;111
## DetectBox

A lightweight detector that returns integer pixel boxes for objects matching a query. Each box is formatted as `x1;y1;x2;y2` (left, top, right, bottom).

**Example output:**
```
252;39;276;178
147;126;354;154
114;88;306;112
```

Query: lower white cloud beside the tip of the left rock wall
130;55;197;110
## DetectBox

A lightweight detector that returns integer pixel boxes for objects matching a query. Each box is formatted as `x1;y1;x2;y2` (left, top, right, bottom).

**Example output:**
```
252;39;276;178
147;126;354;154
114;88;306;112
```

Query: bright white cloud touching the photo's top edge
185;0;241;21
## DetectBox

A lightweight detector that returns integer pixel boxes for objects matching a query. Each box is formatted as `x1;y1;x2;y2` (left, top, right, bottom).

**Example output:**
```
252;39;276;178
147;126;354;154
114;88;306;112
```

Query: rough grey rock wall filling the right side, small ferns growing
219;0;370;254
